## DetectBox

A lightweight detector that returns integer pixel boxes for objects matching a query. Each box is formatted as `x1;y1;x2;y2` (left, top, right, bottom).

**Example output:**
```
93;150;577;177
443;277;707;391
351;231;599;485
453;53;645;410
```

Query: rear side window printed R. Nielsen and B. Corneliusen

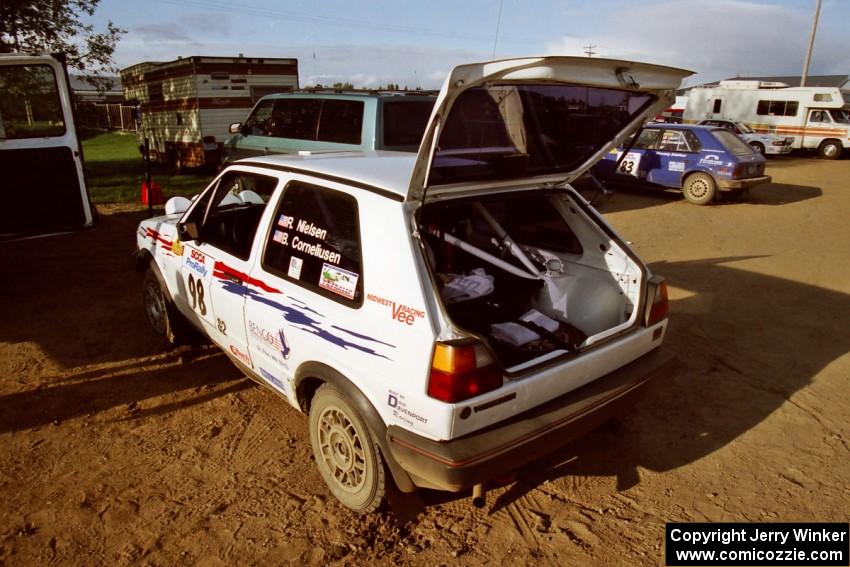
262;181;363;307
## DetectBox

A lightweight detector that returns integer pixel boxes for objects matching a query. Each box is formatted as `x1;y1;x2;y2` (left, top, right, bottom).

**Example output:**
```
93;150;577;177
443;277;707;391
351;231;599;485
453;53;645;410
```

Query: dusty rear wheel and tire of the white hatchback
310;384;387;514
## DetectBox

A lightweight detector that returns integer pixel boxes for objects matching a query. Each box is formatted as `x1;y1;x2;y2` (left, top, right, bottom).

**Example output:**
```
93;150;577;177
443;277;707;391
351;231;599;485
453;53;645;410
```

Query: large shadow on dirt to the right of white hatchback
392;257;850;517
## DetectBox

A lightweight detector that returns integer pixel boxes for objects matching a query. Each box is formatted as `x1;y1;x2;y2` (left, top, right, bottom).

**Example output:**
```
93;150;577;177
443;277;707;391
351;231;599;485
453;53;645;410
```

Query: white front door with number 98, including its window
181;168;279;367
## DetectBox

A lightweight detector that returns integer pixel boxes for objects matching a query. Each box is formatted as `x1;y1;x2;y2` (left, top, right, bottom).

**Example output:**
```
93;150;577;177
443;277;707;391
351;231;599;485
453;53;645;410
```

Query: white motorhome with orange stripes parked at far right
684;81;850;159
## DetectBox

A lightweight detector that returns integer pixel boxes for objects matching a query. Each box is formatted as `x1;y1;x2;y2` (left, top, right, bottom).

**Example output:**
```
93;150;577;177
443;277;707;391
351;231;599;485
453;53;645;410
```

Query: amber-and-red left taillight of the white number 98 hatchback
428;343;502;403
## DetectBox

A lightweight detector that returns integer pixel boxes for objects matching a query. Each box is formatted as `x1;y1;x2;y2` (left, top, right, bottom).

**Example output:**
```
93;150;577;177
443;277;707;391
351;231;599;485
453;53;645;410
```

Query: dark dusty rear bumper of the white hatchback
387;349;675;492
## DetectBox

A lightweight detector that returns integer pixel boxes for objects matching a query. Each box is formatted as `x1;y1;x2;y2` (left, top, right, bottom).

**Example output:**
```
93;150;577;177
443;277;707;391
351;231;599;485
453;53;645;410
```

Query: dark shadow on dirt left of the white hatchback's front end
0;211;169;368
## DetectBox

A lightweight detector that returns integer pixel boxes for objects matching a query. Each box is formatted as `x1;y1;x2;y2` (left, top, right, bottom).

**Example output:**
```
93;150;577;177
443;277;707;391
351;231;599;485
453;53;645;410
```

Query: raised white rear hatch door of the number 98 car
407;57;692;201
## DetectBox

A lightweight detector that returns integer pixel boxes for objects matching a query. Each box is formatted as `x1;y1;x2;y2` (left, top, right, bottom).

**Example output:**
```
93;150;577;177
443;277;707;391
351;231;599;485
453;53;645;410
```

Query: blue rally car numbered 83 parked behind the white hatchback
596;124;770;205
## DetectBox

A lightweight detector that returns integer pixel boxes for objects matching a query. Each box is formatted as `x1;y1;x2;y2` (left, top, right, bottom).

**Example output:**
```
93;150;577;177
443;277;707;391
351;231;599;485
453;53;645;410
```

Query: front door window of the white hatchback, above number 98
187;171;278;260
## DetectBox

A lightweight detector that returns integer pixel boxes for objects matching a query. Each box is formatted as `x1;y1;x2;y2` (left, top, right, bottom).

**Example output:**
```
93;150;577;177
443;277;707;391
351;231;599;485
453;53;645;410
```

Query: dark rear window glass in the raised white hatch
430;84;655;185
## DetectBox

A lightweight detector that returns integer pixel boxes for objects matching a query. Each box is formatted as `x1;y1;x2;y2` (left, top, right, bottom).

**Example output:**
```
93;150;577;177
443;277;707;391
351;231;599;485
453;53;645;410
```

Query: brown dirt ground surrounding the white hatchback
0;158;850;565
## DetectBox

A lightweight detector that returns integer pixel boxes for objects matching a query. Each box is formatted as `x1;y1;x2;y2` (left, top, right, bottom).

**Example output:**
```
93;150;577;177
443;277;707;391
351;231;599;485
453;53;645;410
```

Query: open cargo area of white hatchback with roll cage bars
418;190;644;371
